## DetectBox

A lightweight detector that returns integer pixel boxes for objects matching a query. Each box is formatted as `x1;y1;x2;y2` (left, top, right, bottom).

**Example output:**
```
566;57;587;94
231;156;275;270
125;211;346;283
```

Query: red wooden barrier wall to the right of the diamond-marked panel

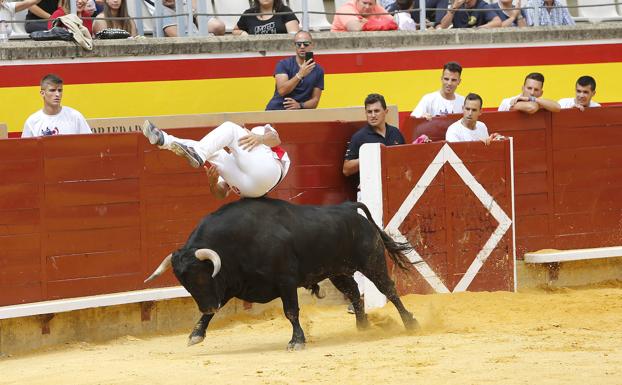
402;106;622;259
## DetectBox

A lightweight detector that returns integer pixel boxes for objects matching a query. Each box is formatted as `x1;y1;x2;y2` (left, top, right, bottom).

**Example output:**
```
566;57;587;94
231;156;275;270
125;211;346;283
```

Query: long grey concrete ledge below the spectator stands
0;22;622;61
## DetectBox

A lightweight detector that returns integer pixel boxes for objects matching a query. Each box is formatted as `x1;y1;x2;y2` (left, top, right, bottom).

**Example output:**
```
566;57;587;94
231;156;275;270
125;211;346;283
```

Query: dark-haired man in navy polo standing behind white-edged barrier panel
343;94;405;184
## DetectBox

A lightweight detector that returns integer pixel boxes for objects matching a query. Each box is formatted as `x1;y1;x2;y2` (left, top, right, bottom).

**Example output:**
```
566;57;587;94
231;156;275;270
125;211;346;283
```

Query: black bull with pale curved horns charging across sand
145;198;417;349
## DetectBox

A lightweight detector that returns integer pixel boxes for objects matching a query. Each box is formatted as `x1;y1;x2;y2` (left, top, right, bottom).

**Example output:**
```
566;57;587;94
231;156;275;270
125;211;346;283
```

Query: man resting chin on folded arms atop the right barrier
499;72;561;114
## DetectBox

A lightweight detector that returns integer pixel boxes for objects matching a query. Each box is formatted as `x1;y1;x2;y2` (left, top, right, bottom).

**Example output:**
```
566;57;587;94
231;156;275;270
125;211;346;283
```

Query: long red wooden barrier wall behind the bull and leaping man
0;122;364;306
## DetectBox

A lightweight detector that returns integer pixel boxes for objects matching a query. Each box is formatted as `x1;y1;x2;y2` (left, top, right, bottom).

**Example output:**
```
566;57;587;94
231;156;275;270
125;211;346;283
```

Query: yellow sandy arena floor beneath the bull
0;282;622;385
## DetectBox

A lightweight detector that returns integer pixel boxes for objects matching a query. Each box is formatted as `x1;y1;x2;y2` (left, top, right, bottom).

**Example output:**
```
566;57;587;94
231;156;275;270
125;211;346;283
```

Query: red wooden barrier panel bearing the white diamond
362;141;514;294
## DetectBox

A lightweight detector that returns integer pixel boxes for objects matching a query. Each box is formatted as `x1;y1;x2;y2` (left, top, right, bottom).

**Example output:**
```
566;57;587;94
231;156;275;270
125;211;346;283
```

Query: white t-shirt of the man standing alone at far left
22;106;91;138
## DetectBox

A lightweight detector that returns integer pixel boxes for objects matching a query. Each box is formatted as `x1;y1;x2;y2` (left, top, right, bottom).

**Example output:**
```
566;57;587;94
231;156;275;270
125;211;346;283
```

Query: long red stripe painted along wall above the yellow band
0;44;622;87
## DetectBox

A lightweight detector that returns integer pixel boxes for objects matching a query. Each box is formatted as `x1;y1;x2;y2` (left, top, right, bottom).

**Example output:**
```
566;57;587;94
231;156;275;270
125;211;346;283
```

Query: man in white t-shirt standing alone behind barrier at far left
22;74;92;138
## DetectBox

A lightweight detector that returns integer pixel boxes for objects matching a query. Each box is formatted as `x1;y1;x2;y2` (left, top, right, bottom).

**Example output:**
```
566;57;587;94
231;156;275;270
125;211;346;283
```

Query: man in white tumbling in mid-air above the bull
143;120;290;198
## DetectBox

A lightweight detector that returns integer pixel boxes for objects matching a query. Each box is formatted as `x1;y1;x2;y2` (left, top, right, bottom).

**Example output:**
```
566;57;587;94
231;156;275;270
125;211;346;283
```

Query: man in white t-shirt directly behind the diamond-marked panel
445;93;502;145
